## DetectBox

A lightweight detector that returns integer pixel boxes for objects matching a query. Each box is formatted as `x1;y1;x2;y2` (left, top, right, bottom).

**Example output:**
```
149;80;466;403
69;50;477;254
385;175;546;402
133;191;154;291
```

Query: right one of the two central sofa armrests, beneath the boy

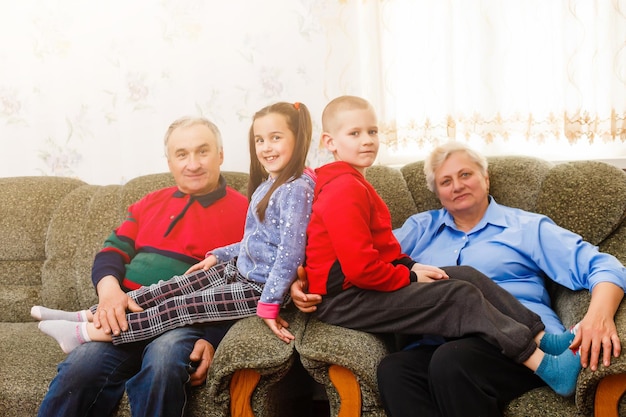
296;317;389;417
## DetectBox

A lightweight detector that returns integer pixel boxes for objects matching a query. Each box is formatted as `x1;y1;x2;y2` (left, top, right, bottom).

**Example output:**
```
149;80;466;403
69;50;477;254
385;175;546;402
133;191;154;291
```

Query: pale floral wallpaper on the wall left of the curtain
0;0;362;184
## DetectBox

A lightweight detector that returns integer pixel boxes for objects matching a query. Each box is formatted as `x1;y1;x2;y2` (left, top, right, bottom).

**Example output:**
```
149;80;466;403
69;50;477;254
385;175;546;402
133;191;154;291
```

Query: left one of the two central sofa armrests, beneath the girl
207;310;306;417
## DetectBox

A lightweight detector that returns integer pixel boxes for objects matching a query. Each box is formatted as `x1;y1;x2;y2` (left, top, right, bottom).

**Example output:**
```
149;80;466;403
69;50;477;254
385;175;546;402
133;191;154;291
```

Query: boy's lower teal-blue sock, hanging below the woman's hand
535;349;582;397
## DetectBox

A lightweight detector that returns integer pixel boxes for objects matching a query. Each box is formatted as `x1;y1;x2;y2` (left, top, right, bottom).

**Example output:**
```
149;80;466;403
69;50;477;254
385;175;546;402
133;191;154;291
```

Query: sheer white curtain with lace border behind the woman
367;0;626;163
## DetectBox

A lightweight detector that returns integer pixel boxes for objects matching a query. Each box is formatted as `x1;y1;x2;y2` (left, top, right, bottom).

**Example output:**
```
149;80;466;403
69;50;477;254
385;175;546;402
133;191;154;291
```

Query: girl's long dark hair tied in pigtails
248;102;313;221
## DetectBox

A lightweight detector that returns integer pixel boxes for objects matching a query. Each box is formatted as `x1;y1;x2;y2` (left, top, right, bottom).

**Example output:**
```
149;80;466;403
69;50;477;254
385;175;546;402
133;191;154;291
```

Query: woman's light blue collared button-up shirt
394;197;626;333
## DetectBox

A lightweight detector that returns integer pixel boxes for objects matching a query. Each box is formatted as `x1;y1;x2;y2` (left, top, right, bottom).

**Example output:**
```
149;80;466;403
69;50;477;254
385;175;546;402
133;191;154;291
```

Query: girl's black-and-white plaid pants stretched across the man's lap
92;259;264;345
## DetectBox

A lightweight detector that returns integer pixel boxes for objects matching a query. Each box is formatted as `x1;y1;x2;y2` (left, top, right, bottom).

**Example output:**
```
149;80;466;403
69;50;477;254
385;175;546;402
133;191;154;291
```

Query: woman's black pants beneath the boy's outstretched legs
378;337;545;417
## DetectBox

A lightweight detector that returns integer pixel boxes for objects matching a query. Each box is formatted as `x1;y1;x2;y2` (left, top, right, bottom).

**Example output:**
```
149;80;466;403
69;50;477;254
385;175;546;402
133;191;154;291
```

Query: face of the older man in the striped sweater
167;124;224;195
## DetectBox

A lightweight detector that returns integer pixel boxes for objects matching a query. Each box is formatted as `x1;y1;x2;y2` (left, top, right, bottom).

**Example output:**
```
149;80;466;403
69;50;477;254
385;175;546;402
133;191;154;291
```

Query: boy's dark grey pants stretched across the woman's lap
316;266;545;363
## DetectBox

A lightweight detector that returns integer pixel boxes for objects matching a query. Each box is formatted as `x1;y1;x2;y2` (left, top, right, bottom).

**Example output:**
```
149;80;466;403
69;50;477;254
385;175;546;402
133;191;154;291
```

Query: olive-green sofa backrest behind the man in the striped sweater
0;172;248;322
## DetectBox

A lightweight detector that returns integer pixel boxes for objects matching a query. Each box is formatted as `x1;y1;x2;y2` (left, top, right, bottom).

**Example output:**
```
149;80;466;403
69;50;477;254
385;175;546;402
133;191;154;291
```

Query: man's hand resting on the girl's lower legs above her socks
93;275;143;335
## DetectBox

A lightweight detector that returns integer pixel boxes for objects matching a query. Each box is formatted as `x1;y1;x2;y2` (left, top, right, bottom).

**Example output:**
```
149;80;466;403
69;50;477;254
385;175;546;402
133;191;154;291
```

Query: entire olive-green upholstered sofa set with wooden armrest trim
0;157;626;417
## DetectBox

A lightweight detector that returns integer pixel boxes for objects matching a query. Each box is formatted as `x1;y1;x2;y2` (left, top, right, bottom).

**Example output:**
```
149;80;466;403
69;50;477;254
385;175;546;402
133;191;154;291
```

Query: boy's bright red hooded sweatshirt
305;161;417;294
